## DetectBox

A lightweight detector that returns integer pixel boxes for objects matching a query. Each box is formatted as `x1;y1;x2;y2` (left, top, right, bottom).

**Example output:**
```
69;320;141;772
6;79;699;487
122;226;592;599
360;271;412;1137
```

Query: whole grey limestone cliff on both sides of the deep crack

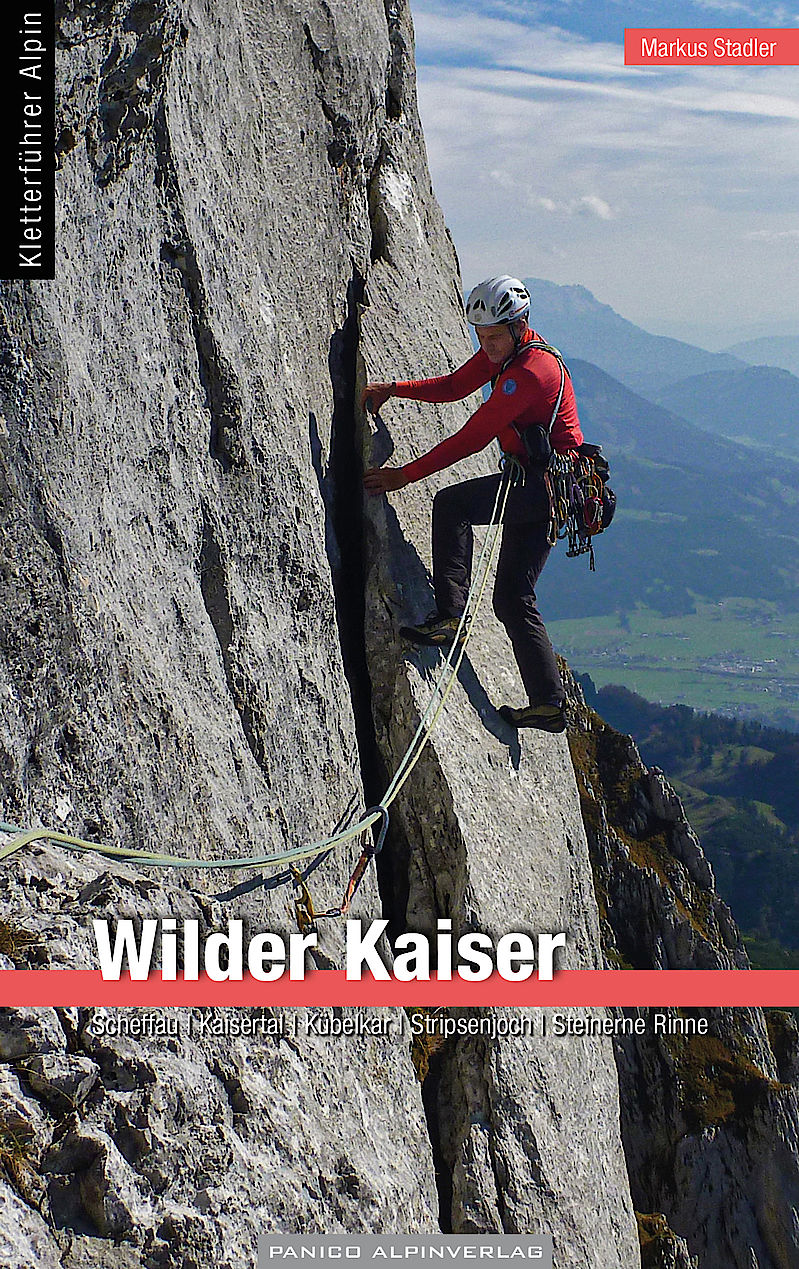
0;0;796;1269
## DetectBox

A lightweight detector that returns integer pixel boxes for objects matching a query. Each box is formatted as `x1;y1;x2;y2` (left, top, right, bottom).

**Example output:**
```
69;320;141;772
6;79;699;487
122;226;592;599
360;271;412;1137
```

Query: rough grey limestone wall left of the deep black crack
0;0;443;1269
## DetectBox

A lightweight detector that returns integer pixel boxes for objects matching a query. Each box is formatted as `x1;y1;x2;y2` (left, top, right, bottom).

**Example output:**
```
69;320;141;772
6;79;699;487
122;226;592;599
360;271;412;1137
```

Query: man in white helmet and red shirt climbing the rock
361;277;582;732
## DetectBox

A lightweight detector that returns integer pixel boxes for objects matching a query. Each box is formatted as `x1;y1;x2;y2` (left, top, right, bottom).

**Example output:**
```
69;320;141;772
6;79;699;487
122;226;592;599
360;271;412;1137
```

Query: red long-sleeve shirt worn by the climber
394;331;582;482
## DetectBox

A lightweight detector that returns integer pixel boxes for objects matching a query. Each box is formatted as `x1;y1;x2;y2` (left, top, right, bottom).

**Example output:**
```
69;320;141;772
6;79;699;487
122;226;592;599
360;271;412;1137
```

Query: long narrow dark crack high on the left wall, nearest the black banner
153;104;244;472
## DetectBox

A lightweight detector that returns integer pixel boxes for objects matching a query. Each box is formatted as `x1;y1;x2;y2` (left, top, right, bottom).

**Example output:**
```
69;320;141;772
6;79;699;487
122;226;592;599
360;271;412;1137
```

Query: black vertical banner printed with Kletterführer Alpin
0;0;56;279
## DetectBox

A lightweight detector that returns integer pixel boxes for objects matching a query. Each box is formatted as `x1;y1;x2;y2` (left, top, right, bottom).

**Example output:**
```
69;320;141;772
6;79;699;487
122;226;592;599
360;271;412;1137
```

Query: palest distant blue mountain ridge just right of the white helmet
524;278;746;396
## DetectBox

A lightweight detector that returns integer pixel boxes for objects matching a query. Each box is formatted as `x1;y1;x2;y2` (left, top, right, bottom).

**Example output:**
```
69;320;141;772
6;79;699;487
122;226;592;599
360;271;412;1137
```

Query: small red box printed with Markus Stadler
624;27;799;66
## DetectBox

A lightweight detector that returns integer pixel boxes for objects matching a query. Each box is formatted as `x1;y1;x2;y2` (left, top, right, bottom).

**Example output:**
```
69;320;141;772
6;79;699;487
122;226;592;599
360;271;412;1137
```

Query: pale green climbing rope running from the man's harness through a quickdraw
0;456;524;913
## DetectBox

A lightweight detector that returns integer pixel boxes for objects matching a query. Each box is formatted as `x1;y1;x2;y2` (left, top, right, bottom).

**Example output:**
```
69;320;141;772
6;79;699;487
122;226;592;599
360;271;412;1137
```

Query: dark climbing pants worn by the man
432;473;563;704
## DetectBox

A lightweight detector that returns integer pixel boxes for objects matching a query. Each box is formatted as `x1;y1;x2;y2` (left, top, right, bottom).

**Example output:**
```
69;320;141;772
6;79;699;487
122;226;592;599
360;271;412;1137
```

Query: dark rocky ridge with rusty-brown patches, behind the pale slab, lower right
569;683;799;1269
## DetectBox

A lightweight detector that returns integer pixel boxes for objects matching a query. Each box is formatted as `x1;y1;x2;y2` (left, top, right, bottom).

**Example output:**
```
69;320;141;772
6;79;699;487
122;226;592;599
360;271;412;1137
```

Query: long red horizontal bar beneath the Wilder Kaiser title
0;970;799;1009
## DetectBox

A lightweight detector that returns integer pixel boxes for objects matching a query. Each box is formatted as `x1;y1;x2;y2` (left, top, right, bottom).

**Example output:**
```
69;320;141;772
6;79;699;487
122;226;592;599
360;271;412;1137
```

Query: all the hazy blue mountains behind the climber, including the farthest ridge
525;279;799;618
